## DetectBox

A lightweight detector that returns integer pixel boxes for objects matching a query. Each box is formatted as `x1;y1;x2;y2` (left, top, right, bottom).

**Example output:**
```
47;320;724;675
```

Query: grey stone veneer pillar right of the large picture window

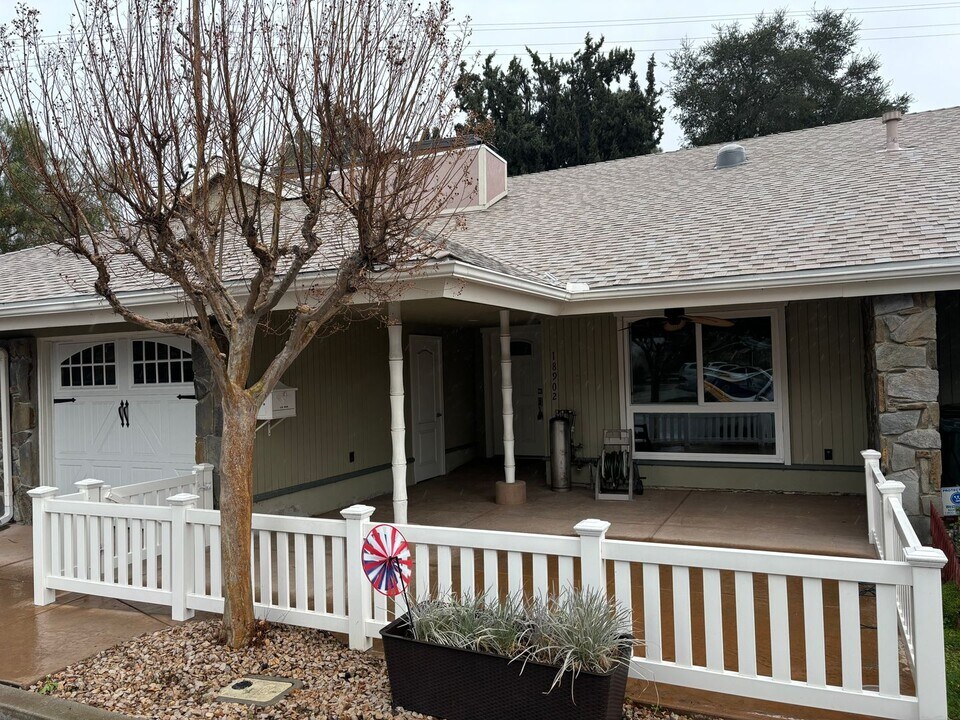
868;293;941;538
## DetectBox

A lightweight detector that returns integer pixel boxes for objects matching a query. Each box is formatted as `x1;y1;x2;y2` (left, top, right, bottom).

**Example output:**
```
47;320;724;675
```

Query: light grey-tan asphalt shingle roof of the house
0;107;960;307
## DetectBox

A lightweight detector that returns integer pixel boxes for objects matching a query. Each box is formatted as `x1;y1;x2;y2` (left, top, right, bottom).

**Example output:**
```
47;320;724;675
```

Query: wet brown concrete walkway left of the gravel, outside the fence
0;525;175;687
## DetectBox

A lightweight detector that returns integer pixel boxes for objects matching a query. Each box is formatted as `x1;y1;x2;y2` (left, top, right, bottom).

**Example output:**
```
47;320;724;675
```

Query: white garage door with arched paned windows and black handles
51;335;196;492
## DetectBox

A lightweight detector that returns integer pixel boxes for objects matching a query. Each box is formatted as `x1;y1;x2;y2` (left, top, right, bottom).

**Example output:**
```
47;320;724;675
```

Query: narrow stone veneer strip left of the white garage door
0;338;40;523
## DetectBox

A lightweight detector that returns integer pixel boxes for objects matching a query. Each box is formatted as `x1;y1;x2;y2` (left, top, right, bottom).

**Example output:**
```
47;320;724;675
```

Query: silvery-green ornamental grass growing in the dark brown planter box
410;589;635;690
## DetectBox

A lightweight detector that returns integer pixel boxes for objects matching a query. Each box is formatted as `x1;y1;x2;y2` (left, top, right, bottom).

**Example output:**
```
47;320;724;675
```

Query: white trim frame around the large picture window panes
618;305;790;465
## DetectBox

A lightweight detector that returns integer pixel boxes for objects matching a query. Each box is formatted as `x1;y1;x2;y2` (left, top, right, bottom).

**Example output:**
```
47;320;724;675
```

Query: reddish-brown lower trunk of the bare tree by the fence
220;388;257;648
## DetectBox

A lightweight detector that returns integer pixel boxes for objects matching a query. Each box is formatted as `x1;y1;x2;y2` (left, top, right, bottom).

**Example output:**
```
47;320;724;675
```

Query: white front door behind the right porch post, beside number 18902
487;327;546;457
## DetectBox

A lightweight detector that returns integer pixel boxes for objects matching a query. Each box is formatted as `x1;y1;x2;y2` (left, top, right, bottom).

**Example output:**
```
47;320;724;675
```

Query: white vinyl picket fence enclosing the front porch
30;456;946;720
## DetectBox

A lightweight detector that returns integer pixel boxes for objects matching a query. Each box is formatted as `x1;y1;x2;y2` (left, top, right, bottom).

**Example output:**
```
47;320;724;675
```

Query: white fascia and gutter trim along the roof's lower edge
0;258;960;332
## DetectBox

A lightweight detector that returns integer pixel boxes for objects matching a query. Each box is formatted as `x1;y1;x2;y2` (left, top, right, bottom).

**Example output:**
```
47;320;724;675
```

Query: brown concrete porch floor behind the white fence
356;461;876;558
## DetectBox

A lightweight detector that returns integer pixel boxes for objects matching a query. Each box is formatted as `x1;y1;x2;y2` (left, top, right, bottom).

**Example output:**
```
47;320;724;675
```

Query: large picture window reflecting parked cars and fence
625;311;783;462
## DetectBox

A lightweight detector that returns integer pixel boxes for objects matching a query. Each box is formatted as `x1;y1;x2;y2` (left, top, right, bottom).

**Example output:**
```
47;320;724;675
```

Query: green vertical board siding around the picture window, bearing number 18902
543;299;867;492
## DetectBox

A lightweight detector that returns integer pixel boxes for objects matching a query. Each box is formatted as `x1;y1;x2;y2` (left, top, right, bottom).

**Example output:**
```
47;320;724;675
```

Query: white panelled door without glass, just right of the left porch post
410;335;446;482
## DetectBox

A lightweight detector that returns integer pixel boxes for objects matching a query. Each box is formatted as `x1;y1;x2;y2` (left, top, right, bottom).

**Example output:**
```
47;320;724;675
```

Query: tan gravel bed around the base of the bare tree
33;621;693;720
